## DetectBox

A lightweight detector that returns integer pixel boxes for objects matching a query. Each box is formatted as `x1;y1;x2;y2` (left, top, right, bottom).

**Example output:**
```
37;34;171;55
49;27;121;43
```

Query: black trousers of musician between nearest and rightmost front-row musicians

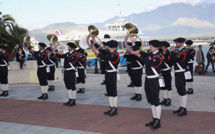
161;70;172;91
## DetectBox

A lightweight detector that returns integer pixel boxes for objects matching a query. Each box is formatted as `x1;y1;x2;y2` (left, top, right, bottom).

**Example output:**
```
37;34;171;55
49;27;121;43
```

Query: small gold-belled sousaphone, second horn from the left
47;34;64;51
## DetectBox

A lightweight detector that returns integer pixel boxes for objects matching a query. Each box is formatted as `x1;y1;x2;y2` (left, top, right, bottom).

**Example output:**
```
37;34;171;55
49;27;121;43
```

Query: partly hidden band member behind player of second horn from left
77;48;87;93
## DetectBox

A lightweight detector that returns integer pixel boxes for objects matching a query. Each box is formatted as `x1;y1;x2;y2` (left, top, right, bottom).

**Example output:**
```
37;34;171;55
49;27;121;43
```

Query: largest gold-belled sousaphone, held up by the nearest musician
124;23;143;51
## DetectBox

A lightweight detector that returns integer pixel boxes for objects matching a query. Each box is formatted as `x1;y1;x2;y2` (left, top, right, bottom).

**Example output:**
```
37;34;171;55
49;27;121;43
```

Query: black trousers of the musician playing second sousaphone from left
64;70;76;91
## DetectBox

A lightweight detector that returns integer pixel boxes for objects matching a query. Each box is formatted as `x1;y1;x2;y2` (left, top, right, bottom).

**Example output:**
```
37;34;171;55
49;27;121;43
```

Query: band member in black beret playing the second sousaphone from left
56;42;78;107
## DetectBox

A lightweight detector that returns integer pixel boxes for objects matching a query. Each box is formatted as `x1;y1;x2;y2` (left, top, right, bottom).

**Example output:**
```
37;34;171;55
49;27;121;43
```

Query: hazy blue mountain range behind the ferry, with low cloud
29;3;215;41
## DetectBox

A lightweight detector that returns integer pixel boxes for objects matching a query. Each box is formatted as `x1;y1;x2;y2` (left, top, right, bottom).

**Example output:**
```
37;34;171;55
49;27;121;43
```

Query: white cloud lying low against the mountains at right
170;18;215;28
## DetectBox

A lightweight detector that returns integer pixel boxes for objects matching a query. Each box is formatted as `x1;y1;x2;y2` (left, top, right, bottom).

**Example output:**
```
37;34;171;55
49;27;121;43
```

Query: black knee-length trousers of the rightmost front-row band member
175;72;186;96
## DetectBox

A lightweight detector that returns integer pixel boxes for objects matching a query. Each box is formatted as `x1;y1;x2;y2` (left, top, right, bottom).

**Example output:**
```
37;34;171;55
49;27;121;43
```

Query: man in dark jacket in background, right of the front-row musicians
196;45;205;74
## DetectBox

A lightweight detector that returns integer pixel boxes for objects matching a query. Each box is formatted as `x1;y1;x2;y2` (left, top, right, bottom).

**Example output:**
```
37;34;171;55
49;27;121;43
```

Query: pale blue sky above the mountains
0;0;215;30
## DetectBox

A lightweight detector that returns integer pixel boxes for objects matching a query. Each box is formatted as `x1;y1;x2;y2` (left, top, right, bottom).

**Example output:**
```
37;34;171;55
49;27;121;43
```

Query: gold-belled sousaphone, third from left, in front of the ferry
85;25;102;49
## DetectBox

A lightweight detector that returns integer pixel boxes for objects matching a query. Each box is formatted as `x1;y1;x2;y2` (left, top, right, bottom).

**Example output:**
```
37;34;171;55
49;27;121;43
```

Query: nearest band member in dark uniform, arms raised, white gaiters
130;40;163;130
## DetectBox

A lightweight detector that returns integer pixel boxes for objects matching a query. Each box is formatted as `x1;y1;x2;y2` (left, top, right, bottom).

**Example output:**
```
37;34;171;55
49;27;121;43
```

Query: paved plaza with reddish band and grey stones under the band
0;68;215;134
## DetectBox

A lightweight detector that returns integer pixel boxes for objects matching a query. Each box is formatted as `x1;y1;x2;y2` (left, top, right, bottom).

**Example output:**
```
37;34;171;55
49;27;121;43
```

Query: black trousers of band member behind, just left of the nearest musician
131;69;143;87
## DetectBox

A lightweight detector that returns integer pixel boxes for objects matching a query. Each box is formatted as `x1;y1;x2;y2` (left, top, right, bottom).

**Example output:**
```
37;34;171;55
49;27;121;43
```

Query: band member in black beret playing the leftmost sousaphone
29;42;48;100
